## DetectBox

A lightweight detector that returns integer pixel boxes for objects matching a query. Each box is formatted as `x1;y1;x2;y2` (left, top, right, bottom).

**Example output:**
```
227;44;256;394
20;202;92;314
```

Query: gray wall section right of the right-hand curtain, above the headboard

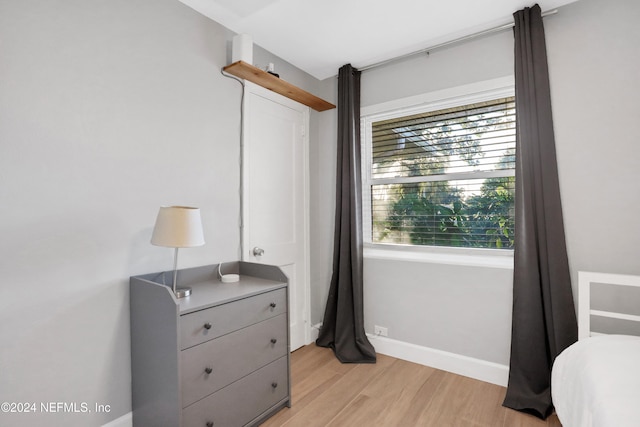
546;0;640;282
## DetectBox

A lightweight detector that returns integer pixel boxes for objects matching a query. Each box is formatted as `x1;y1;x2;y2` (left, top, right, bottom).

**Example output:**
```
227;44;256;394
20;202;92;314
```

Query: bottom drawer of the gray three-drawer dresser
182;356;289;427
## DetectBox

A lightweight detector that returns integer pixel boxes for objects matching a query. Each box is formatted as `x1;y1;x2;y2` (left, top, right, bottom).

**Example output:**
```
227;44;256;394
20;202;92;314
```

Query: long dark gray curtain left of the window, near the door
316;64;376;363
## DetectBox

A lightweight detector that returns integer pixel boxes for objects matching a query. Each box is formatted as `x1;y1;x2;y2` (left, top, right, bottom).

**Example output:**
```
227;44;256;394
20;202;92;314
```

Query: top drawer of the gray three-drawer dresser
180;288;287;349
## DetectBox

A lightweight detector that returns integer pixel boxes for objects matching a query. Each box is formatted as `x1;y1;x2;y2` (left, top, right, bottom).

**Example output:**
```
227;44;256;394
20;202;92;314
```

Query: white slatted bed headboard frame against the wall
578;271;640;340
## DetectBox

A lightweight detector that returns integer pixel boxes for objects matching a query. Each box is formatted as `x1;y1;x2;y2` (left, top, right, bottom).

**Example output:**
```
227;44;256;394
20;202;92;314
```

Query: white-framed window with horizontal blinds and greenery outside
362;91;515;249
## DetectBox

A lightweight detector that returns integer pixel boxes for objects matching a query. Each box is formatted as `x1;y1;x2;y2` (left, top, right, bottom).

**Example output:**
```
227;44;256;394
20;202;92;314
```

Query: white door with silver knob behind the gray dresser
242;82;310;351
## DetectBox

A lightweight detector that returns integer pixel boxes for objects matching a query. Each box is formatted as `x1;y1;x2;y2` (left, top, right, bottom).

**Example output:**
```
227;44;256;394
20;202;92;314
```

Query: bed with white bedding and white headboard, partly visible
551;272;640;427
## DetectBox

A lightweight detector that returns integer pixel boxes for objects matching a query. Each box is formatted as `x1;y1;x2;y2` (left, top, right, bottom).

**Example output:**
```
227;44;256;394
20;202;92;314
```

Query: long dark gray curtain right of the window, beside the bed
503;5;578;418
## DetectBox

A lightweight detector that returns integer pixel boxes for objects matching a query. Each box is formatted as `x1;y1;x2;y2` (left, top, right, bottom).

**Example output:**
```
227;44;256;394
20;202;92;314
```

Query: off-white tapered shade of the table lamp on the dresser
151;206;204;248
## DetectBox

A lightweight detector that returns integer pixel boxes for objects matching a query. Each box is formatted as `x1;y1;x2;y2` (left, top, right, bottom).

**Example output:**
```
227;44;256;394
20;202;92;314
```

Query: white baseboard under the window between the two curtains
367;334;509;387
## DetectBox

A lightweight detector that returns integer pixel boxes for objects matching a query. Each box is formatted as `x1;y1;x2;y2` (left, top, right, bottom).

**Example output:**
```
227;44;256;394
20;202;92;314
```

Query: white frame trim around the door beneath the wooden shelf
240;80;312;345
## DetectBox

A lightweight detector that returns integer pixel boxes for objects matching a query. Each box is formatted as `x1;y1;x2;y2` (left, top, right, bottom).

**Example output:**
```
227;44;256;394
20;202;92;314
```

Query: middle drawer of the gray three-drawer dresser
180;314;288;407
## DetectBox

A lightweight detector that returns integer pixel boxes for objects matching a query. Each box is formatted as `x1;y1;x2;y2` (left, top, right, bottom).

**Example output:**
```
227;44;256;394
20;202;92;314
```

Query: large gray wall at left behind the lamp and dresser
0;0;319;426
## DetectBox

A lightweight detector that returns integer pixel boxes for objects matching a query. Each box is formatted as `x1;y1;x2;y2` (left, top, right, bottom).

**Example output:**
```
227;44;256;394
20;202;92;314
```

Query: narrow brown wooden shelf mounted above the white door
223;61;336;111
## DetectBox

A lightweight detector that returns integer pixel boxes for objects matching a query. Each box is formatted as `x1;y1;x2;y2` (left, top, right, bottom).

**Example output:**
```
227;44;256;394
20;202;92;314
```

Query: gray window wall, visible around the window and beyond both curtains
312;0;640;364
